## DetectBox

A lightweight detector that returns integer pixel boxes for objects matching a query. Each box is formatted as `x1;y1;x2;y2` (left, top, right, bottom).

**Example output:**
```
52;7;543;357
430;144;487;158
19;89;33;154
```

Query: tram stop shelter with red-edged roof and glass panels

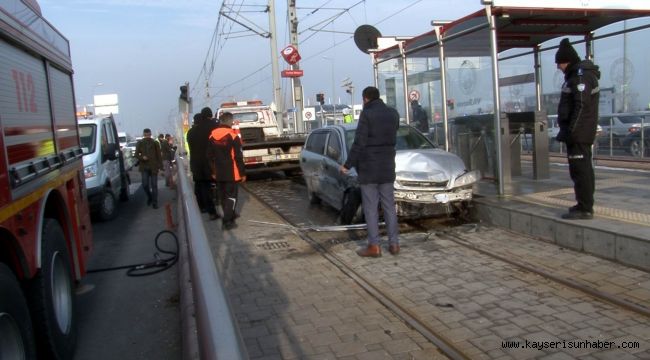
371;0;650;195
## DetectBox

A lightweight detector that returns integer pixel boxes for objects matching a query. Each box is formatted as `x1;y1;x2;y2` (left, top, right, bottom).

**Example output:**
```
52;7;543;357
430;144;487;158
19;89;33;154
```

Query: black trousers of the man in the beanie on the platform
567;144;596;213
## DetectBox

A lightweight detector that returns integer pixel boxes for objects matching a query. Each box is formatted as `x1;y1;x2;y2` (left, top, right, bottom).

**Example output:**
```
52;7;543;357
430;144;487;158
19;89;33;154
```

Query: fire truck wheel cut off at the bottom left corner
0;263;36;359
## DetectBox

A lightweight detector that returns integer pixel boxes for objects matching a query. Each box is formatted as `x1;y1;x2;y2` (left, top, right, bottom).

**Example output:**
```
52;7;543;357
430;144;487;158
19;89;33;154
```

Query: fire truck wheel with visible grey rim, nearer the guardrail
29;218;77;359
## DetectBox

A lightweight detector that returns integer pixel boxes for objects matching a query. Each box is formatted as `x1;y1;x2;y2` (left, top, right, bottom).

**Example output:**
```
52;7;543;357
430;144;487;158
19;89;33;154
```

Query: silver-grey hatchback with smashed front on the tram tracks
300;124;480;224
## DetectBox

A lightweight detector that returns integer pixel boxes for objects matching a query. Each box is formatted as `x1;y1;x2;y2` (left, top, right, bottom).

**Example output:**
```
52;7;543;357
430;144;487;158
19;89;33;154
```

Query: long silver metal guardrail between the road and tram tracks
176;155;248;360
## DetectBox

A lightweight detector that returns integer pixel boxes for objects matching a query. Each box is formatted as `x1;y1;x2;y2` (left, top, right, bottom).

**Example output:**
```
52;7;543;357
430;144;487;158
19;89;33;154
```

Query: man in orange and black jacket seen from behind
207;112;246;230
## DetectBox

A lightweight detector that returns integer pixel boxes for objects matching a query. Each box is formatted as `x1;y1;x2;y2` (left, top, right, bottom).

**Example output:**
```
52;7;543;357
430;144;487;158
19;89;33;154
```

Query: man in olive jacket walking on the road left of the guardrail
135;128;162;209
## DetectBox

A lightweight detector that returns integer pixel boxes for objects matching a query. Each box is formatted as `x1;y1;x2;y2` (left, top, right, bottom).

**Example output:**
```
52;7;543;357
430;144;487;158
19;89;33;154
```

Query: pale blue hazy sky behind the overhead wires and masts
39;0;482;135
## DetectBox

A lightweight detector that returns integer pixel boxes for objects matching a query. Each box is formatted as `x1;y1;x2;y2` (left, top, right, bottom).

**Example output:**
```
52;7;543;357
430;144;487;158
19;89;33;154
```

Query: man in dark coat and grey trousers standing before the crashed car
340;86;400;257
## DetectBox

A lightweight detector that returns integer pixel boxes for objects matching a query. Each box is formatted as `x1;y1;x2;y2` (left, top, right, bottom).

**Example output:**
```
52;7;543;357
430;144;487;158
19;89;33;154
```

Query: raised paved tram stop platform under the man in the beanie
473;162;650;271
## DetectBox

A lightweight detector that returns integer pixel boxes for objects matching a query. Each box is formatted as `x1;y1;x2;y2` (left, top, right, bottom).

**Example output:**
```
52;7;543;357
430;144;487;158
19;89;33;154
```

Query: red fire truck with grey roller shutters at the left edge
0;0;92;359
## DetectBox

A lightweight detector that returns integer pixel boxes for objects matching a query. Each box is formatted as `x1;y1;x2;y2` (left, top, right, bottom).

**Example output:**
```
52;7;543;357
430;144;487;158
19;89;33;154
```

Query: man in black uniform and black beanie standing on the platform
555;38;600;220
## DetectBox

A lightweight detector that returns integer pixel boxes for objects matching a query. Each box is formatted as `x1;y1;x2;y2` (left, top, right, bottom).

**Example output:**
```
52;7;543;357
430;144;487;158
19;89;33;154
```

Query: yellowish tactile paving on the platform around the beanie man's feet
513;176;650;226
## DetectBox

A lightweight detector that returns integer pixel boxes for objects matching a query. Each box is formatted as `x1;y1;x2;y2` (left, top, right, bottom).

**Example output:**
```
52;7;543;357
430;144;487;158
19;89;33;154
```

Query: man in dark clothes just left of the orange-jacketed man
187;107;219;220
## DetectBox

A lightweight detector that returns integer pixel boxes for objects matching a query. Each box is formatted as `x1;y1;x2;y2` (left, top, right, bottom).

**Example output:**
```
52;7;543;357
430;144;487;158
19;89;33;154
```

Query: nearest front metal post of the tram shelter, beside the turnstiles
485;5;506;196
